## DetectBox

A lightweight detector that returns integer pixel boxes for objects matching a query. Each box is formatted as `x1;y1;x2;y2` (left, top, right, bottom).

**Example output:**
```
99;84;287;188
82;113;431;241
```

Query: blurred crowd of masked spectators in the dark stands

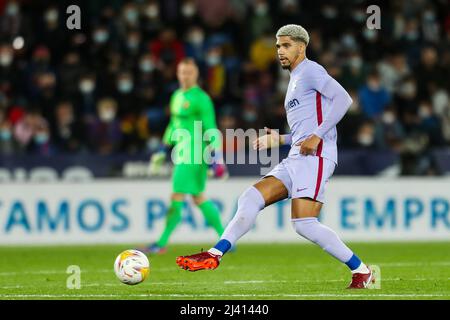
0;0;450;174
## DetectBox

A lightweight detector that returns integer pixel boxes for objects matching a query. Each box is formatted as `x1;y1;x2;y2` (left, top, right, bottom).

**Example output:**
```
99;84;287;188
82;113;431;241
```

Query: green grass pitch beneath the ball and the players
0;242;450;300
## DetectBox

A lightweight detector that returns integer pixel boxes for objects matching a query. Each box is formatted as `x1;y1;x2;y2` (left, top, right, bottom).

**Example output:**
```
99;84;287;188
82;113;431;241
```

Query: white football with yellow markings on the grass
114;250;150;285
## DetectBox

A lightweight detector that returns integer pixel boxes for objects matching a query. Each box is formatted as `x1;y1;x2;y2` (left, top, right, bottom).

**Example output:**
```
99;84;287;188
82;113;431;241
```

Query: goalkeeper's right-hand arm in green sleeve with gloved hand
199;94;227;178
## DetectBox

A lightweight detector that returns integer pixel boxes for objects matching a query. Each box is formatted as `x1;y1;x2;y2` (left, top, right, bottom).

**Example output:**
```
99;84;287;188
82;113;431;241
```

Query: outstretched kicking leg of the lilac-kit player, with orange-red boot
176;176;288;271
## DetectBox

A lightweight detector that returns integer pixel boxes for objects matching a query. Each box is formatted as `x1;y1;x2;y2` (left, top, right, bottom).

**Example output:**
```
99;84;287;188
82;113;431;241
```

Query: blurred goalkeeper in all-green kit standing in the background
140;58;227;253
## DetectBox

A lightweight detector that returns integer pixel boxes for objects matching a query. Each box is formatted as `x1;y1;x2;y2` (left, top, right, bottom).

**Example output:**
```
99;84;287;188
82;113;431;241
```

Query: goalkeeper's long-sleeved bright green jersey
163;85;222;165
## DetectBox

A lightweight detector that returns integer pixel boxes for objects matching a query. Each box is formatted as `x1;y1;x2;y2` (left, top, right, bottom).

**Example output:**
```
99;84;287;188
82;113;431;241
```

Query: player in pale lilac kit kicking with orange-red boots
176;24;372;288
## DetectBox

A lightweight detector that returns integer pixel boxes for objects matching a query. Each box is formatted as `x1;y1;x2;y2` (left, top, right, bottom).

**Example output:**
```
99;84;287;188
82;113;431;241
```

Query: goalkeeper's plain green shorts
172;164;208;195
